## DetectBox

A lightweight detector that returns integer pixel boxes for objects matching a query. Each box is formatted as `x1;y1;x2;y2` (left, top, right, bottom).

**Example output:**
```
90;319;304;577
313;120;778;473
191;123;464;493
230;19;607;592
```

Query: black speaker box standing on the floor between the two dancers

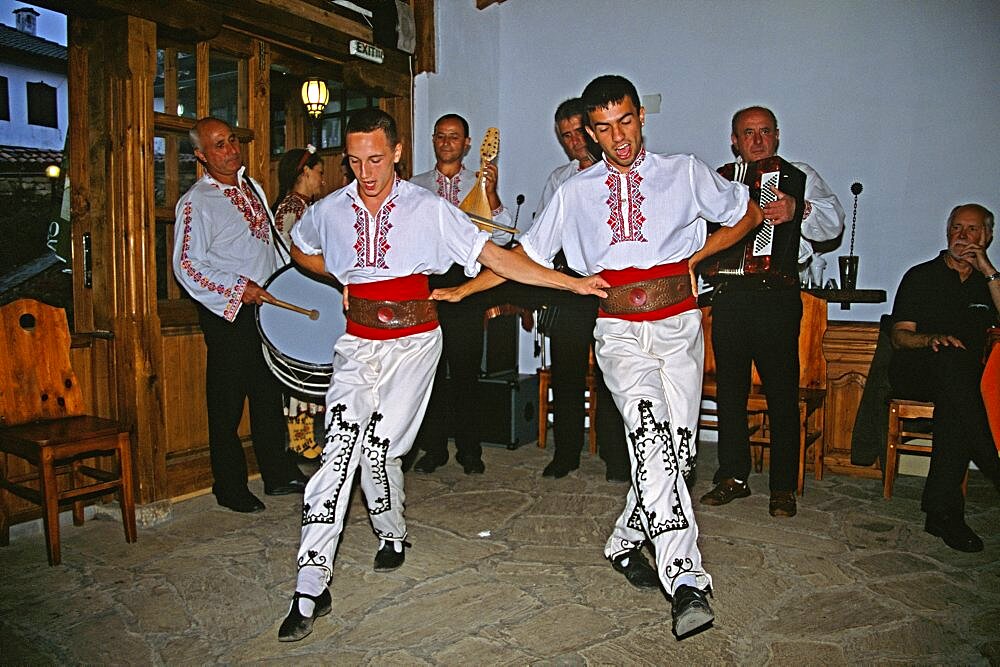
478;373;538;449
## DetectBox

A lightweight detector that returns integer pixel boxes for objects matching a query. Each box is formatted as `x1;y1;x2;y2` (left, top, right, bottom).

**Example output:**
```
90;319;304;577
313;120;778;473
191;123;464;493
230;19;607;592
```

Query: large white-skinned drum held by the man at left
257;264;347;403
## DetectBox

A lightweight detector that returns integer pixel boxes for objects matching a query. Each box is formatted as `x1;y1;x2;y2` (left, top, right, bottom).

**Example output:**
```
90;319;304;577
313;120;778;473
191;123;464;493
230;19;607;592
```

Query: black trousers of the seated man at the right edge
890;347;1000;516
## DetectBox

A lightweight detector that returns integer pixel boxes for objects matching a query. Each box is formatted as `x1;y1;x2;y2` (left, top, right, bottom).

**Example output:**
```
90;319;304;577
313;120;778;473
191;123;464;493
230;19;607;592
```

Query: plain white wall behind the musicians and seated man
414;0;1000;328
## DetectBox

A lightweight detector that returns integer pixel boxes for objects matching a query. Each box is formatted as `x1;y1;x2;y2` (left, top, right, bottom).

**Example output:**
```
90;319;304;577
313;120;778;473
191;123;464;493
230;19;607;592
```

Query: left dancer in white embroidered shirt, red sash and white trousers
278;109;605;641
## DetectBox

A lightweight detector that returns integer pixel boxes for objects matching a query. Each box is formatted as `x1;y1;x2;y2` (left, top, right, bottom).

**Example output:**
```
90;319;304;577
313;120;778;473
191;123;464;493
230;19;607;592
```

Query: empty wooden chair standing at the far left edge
0;299;136;565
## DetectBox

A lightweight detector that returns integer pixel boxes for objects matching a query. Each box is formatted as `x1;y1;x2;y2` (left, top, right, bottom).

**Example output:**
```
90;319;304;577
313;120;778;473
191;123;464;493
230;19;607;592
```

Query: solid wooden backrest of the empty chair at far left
0;299;85;426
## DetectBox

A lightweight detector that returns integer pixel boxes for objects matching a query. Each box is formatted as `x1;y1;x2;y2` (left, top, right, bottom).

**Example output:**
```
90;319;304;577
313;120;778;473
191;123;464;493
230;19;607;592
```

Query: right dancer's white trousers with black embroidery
594;309;712;594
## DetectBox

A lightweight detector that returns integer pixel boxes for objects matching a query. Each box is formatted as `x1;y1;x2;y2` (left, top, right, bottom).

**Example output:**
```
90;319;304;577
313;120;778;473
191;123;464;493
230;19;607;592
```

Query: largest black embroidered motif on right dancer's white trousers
628;400;690;539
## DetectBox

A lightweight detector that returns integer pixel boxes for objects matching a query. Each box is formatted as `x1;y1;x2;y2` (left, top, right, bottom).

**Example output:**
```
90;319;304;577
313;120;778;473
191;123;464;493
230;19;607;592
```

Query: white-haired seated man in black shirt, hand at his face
889;204;1000;551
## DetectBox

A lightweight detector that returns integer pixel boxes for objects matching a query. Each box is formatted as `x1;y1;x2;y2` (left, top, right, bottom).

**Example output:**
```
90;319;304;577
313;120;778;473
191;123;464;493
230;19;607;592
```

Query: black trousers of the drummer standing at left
198;305;301;500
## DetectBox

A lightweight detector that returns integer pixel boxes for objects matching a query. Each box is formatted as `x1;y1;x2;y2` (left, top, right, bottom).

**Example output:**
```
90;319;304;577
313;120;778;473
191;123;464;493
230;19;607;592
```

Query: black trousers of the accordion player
712;286;802;493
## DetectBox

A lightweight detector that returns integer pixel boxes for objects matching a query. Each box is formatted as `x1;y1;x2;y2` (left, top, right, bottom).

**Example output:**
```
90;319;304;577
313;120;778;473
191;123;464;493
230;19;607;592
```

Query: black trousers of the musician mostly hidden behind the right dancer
550;295;628;471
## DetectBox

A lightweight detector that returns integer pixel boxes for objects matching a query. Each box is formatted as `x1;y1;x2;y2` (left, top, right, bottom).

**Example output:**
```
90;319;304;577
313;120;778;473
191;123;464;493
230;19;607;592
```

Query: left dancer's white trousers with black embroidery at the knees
298;329;441;590
